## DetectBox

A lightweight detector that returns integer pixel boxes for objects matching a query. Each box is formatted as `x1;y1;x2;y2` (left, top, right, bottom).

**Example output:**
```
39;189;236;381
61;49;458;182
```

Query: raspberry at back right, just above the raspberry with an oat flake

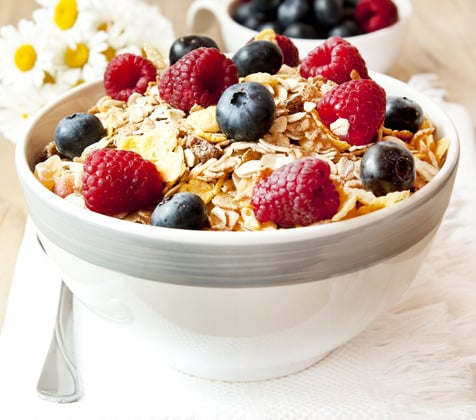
299;36;369;84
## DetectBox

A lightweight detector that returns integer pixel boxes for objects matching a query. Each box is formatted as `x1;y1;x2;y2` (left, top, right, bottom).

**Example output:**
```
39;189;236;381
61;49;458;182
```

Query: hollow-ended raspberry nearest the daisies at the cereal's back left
104;53;157;101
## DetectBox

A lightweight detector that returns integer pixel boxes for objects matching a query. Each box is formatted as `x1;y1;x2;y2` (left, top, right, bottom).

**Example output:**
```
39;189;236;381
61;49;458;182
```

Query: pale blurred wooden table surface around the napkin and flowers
0;0;476;330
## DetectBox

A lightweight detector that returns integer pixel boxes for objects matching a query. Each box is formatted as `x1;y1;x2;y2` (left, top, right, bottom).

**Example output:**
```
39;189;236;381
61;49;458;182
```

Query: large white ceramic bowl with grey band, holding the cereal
16;74;459;380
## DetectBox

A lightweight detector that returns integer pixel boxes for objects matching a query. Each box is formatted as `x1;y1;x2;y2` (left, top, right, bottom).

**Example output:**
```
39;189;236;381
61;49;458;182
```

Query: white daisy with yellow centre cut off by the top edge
33;0;96;45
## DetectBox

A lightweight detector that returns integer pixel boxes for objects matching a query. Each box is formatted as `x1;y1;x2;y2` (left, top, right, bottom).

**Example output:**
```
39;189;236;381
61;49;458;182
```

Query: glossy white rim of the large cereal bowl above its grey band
15;72;460;246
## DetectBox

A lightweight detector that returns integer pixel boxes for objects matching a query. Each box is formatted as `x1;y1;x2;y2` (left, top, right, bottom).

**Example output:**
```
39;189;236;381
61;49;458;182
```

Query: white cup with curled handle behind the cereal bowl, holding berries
187;0;412;73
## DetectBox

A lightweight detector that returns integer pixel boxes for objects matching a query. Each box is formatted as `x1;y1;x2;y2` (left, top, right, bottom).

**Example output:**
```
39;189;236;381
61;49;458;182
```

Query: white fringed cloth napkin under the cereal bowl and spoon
0;75;476;420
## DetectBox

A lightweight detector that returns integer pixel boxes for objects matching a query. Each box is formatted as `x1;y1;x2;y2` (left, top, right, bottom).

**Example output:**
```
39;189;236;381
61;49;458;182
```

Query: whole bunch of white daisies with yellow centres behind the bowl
0;0;175;142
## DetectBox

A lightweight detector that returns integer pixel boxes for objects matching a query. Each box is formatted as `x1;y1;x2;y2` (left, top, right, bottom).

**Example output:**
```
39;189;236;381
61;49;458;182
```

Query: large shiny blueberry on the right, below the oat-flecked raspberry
360;140;416;196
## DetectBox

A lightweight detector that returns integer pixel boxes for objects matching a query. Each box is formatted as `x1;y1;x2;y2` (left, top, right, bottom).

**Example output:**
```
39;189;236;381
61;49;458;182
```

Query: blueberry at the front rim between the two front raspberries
151;192;208;230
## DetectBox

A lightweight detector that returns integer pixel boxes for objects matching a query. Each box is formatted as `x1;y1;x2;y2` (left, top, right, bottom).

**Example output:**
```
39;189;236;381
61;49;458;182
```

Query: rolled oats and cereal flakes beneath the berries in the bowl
35;64;450;231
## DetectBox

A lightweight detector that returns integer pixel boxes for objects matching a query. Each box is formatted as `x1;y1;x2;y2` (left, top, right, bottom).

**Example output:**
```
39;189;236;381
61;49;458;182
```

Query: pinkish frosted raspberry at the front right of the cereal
251;157;340;227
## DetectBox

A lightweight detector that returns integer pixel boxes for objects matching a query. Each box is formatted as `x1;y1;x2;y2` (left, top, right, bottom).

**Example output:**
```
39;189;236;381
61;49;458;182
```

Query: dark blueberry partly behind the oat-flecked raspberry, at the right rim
383;96;424;133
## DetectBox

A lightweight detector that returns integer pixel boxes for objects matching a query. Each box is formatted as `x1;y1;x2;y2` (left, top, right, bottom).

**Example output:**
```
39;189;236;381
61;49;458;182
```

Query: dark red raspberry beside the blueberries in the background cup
354;0;398;32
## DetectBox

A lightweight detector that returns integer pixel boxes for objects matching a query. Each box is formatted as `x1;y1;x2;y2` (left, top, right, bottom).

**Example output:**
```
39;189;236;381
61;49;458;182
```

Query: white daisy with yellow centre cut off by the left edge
0;19;52;86
